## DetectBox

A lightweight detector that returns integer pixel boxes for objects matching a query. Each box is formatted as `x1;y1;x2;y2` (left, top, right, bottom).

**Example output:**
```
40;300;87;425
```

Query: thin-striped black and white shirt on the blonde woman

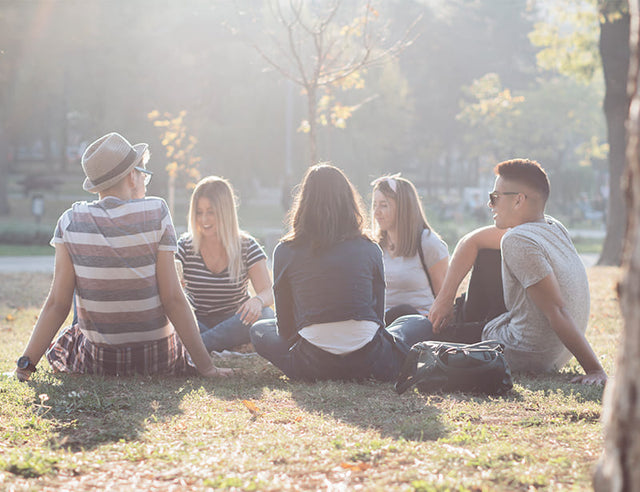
176;234;267;321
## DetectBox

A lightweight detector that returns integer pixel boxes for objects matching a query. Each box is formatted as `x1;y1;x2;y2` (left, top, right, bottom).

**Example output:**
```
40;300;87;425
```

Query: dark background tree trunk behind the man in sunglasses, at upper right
598;14;630;265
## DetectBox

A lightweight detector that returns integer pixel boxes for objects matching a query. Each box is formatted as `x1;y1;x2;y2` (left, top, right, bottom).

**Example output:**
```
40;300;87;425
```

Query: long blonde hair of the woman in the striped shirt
189;176;246;280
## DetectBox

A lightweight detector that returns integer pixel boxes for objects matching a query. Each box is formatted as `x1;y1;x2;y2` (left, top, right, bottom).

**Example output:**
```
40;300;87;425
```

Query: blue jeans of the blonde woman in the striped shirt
198;307;275;352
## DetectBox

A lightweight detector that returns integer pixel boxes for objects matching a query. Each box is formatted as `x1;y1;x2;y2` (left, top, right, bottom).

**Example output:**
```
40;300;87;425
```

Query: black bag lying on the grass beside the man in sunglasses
395;340;513;395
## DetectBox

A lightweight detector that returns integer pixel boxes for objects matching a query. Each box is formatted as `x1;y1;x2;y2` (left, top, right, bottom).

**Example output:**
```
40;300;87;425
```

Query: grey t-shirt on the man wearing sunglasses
482;216;589;372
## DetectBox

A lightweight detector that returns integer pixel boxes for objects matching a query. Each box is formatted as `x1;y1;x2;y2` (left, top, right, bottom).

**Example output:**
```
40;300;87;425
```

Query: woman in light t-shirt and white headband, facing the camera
371;174;449;326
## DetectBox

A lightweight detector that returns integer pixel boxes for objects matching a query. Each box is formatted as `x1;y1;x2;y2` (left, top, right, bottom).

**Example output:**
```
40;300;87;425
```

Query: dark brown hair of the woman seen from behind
282;163;365;250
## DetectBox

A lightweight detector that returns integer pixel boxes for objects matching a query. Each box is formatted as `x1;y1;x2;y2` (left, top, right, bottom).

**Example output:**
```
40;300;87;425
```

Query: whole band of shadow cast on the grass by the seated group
22;357;602;451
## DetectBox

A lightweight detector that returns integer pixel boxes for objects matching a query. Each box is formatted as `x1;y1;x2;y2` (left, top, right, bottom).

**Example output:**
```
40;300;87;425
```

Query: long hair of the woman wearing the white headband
371;175;435;258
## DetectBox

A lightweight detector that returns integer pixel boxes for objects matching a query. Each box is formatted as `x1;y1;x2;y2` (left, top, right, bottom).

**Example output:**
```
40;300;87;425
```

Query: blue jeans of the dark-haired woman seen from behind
250;316;432;381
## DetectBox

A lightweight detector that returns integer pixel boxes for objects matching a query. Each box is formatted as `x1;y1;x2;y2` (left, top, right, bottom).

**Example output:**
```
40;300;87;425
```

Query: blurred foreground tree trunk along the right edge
594;0;640;492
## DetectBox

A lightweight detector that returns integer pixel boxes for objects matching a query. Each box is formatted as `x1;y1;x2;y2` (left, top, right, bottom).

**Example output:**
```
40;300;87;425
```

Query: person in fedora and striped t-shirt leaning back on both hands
16;133;231;381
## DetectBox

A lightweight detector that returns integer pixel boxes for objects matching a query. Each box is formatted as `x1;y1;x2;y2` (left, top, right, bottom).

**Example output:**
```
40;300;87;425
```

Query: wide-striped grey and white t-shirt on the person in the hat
51;197;176;345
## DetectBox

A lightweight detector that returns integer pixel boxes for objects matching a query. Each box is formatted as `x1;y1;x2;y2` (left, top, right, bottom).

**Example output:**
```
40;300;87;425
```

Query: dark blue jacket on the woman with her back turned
273;237;384;340
